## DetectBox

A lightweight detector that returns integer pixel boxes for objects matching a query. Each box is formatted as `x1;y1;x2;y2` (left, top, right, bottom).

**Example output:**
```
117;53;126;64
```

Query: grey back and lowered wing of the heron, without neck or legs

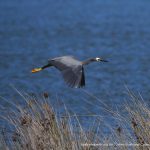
49;56;85;88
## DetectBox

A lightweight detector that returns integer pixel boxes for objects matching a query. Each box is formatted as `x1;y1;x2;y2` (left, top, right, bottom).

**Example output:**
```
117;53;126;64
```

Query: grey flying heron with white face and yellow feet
32;56;107;88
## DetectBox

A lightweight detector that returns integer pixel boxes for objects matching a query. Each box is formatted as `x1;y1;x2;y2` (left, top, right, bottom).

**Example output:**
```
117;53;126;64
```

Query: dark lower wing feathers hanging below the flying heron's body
62;66;85;88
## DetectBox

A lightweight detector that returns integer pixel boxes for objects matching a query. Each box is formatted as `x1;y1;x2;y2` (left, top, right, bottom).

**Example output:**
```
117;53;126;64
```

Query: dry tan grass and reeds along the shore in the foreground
0;90;150;150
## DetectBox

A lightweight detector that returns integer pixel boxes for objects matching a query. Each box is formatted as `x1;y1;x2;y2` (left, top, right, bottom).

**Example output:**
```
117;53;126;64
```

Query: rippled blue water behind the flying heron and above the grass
0;0;150;125
